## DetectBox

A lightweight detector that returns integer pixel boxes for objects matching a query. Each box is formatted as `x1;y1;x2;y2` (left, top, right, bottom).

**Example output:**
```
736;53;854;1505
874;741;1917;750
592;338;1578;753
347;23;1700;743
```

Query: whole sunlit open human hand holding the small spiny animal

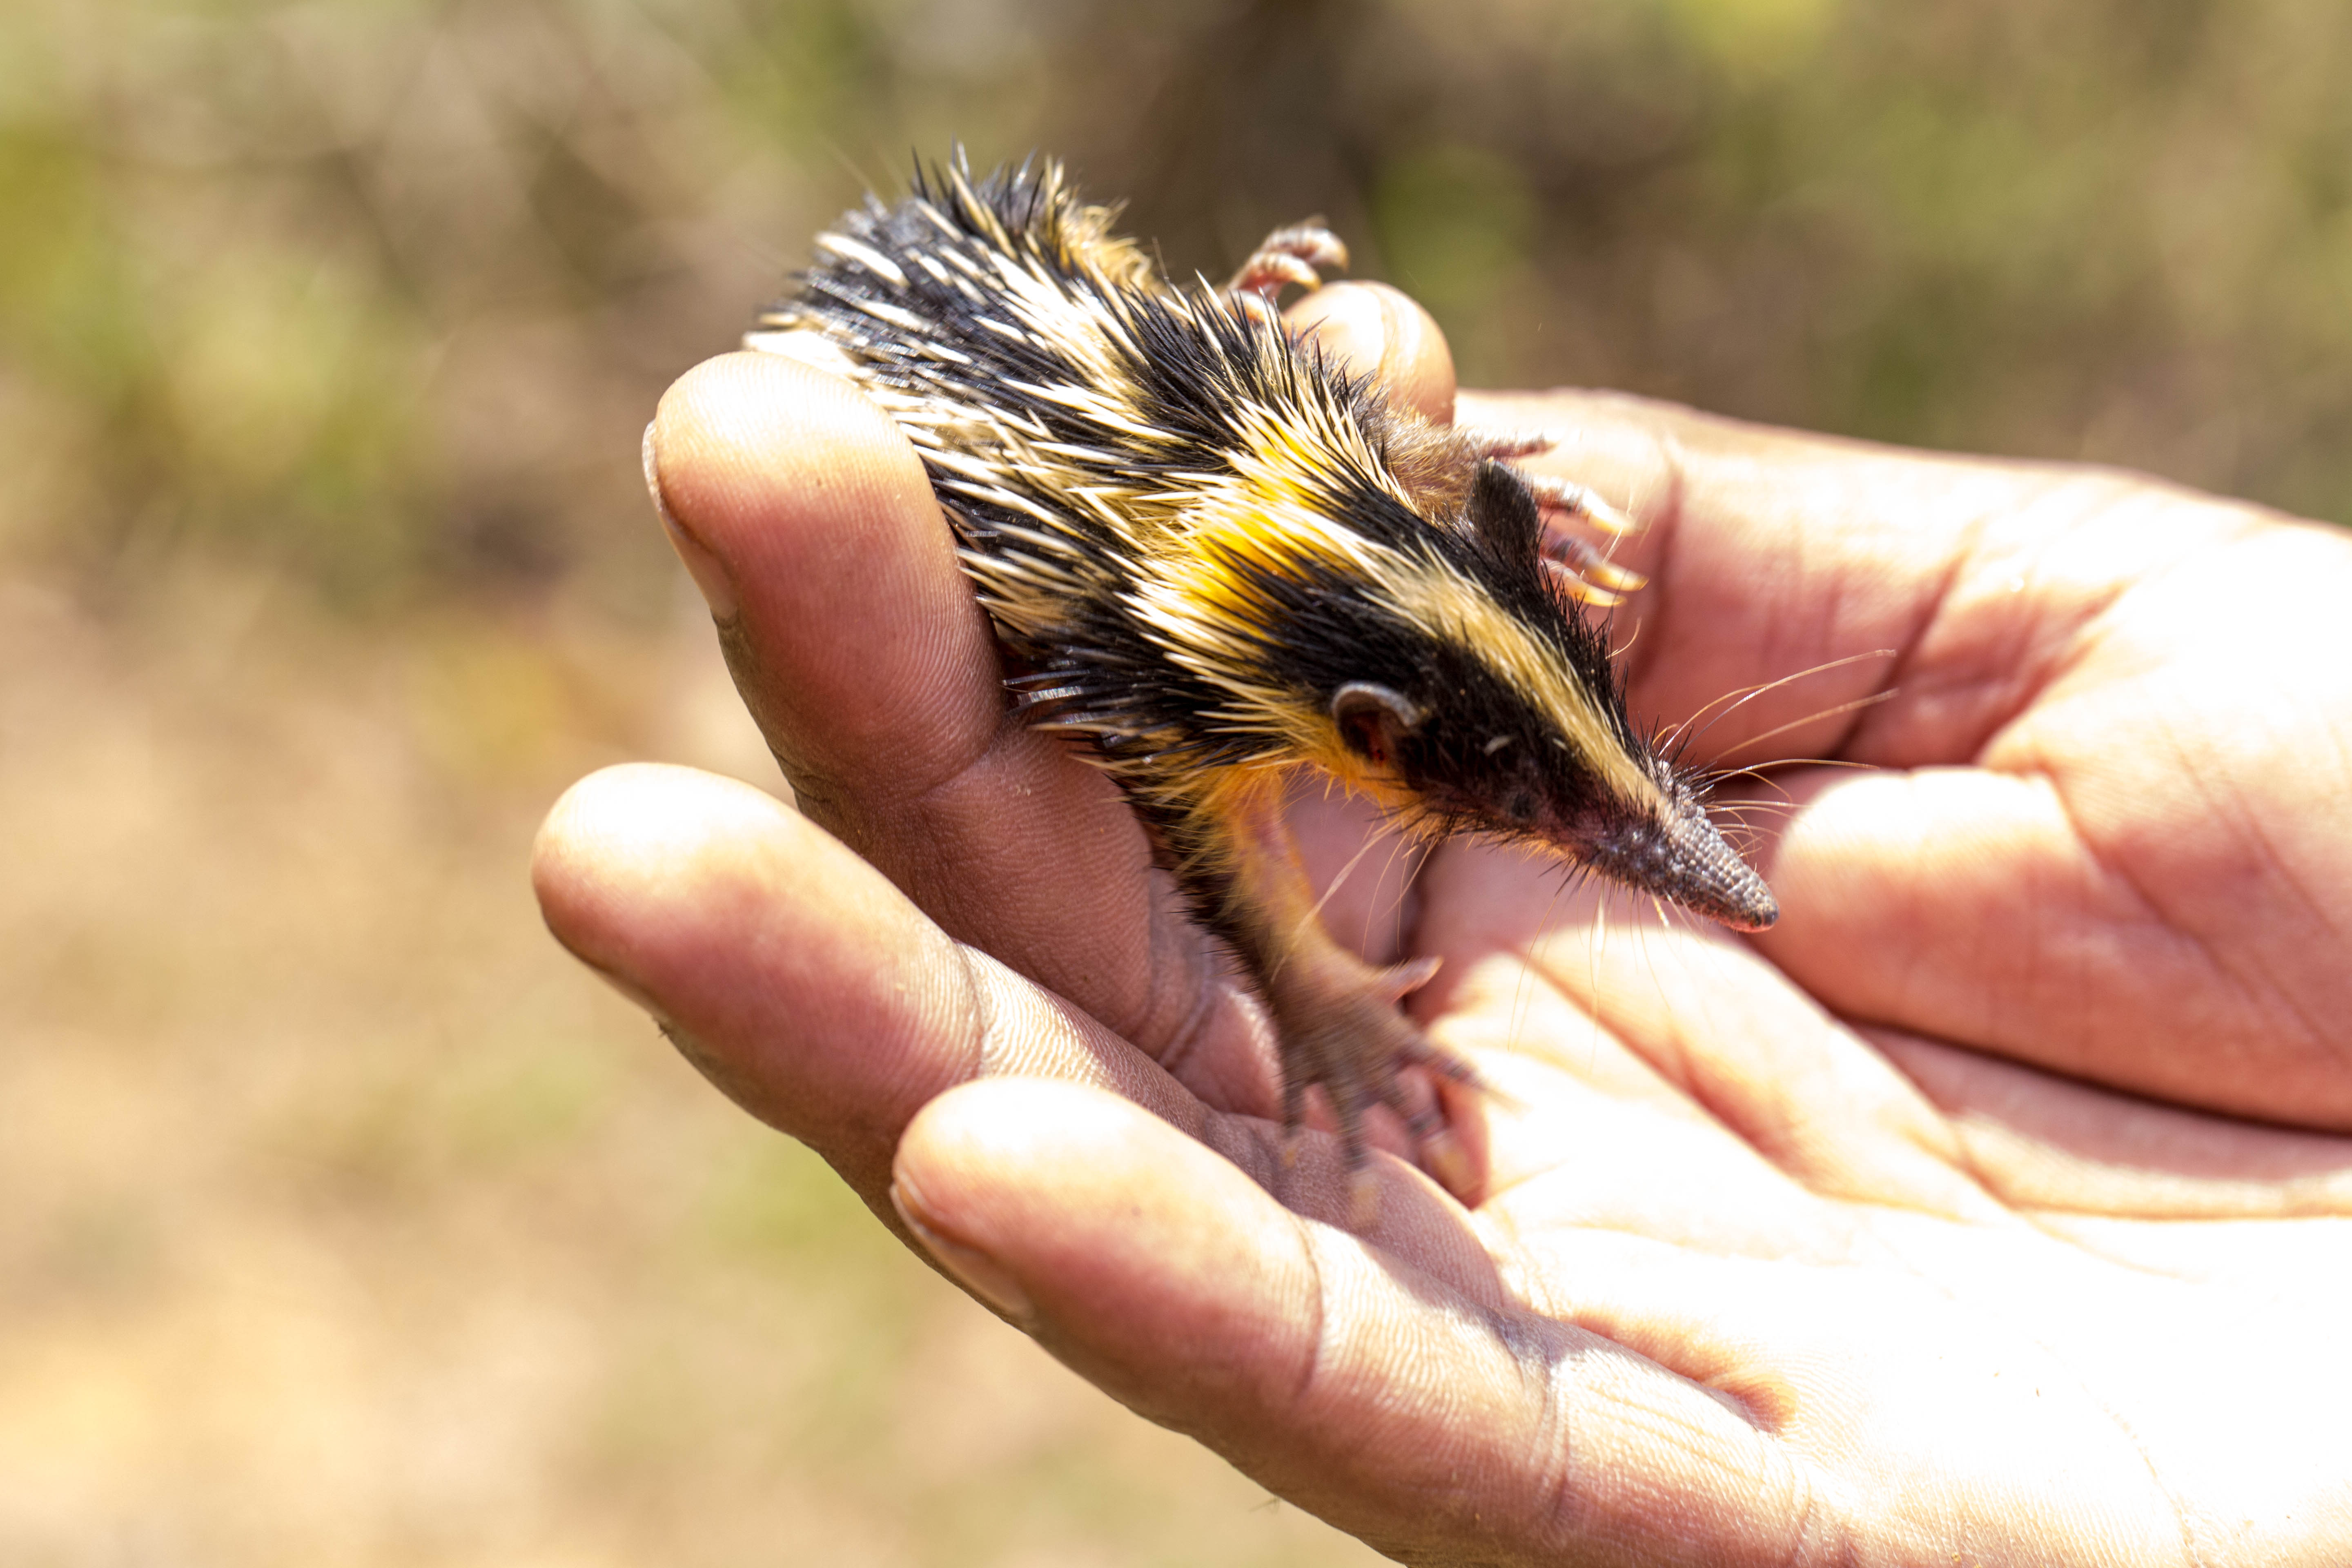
534;287;2352;1568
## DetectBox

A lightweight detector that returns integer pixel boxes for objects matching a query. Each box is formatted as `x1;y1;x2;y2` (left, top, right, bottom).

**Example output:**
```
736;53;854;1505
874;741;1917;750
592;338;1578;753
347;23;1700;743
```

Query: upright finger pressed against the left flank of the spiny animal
652;355;1265;1096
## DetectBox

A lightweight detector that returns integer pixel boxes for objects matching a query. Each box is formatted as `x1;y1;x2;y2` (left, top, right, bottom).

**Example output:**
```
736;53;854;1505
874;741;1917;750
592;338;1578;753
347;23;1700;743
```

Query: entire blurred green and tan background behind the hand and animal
0;0;2352;1566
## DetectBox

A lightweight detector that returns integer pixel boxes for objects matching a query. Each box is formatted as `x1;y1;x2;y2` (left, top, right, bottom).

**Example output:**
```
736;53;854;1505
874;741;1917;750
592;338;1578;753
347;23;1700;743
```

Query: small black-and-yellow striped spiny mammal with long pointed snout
748;153;1778;1218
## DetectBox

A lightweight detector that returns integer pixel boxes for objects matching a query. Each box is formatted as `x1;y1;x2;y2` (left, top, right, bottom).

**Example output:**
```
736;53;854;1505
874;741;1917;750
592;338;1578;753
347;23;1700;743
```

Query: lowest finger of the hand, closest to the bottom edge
894;1081;1797;1563
